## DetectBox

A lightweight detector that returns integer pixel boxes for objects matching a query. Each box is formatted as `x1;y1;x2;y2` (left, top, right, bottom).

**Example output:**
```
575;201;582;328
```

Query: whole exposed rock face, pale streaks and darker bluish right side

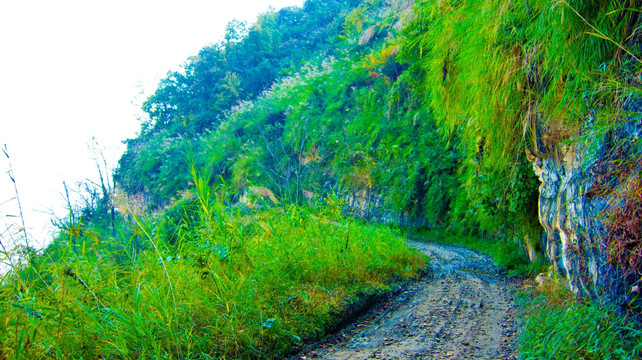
533;114;642;304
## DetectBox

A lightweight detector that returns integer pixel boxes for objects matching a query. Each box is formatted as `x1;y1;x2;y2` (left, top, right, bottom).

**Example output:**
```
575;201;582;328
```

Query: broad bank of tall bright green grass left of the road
0;172;426;359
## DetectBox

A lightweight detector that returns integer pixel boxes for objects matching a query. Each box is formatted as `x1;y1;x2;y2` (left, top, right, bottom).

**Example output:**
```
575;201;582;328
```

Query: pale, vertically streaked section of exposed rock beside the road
533;143;611;296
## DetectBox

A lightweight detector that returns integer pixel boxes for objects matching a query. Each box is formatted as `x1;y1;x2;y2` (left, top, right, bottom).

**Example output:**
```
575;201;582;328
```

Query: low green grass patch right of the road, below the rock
519;279;642;359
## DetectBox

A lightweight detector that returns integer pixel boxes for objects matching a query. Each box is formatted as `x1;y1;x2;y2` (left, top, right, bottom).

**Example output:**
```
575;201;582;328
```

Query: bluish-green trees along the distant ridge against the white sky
116;0;360;207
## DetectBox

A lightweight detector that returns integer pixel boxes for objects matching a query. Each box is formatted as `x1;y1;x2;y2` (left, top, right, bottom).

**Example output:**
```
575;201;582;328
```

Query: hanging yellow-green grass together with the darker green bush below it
400;0;642;238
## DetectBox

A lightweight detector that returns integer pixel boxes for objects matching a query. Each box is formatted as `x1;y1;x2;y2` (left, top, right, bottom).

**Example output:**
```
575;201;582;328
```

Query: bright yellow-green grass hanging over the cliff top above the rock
405;0;641;158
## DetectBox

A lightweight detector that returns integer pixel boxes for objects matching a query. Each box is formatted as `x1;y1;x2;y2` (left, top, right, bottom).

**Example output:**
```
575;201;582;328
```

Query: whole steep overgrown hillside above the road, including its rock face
117;1;640;312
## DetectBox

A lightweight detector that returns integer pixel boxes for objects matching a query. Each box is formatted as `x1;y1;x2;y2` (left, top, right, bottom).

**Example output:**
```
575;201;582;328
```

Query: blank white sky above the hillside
0;0;303;249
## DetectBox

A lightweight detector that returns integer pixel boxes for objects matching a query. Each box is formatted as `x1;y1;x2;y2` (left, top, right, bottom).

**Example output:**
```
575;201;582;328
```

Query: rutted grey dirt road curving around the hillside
295;242;517;359
